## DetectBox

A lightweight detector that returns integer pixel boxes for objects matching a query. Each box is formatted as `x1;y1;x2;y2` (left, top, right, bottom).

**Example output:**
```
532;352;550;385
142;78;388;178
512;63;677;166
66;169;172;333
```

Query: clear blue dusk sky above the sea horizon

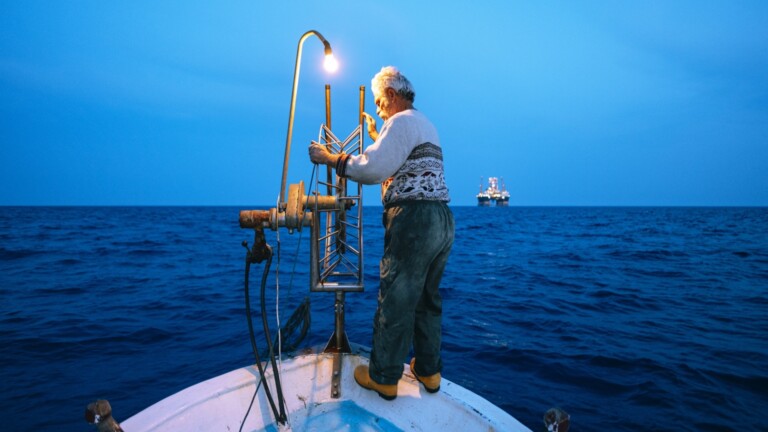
0;0;768;206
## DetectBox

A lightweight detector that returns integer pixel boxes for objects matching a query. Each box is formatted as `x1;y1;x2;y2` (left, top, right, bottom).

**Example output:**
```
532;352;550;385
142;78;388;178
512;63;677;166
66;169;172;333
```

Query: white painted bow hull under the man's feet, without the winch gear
122;348;529;432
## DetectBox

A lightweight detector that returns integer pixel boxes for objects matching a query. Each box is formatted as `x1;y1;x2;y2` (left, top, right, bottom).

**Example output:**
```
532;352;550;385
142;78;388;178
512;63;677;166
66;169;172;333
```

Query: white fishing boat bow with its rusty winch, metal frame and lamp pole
86;32;530;432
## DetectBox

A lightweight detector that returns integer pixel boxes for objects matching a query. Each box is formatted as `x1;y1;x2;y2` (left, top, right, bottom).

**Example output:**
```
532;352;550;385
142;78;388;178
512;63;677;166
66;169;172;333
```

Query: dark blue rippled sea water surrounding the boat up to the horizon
0;207;768;431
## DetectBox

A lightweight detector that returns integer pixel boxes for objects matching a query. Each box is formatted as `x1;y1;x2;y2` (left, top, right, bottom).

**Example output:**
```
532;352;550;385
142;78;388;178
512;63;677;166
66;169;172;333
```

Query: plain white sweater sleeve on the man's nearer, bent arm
344;116;416;184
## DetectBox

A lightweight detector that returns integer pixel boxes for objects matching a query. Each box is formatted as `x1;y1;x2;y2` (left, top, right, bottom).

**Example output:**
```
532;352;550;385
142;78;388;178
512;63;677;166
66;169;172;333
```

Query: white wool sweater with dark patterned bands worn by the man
338;109;451;205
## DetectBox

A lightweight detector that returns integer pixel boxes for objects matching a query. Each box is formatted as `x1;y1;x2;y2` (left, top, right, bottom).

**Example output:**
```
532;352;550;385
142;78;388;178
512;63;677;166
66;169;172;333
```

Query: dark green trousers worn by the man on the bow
369;201;454;384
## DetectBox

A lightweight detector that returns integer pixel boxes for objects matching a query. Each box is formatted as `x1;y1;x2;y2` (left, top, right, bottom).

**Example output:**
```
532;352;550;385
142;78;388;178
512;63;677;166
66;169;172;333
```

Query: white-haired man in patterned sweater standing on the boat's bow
309;66;454;400
